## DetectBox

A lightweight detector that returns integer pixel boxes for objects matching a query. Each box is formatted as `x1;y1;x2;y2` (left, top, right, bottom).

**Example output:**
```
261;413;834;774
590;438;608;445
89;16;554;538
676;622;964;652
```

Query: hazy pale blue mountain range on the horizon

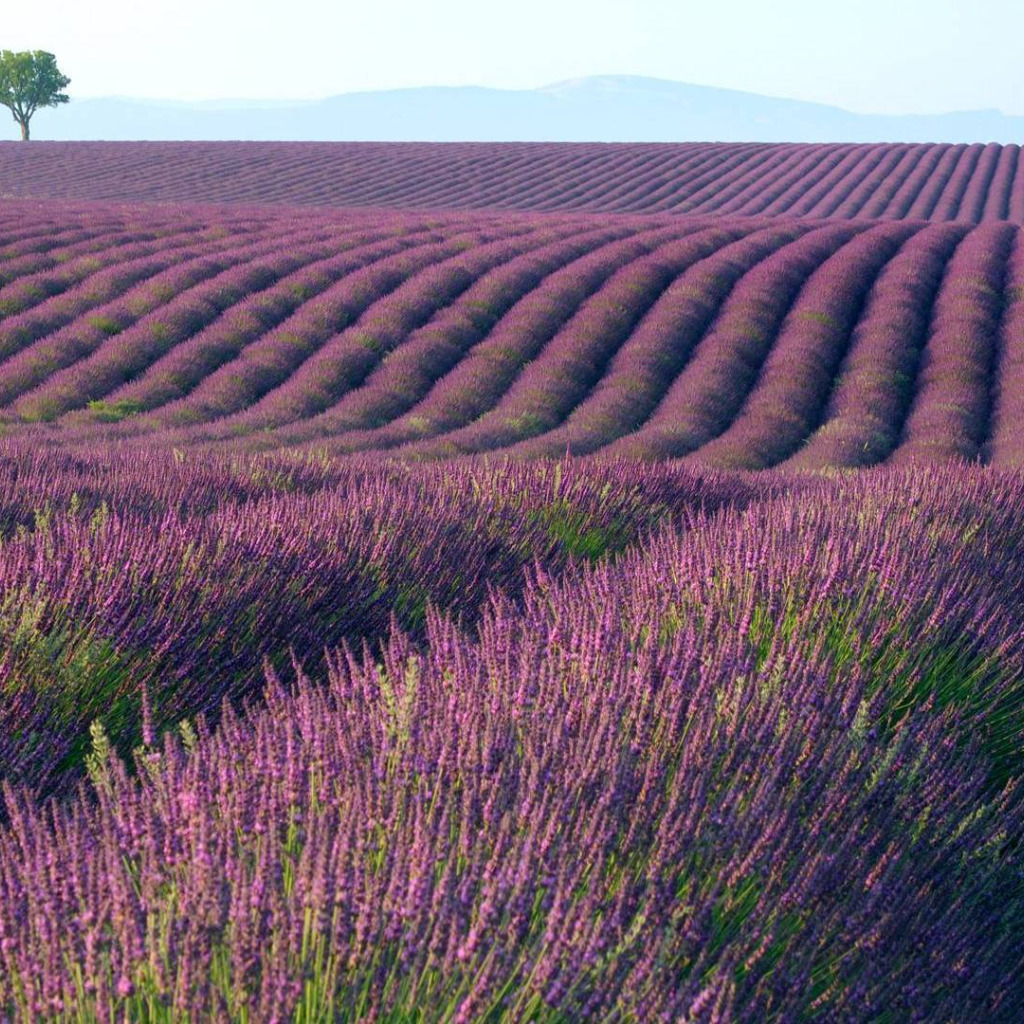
22;75;1024;142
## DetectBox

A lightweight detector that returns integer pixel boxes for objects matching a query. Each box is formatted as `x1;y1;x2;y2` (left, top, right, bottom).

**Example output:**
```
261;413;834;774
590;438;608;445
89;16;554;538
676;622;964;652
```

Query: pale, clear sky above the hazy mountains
14;0;1024;115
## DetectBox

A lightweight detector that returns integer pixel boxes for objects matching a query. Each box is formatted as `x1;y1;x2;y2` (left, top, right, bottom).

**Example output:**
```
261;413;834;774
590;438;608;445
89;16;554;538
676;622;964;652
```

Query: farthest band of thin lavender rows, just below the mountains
6;142;1024;223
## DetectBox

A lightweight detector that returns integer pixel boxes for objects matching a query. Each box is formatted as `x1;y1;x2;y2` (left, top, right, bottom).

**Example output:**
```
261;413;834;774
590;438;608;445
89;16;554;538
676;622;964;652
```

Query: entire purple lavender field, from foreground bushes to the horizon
0;142;1024;1024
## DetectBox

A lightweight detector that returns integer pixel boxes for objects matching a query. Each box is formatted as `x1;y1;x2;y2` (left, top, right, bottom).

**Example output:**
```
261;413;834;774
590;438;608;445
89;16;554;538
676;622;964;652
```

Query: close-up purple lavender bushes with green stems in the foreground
0;442;1024;1022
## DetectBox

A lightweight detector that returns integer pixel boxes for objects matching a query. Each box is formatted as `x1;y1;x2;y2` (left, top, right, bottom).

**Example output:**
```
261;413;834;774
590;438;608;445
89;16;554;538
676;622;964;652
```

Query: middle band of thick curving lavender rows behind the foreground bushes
6;197;1024;469
